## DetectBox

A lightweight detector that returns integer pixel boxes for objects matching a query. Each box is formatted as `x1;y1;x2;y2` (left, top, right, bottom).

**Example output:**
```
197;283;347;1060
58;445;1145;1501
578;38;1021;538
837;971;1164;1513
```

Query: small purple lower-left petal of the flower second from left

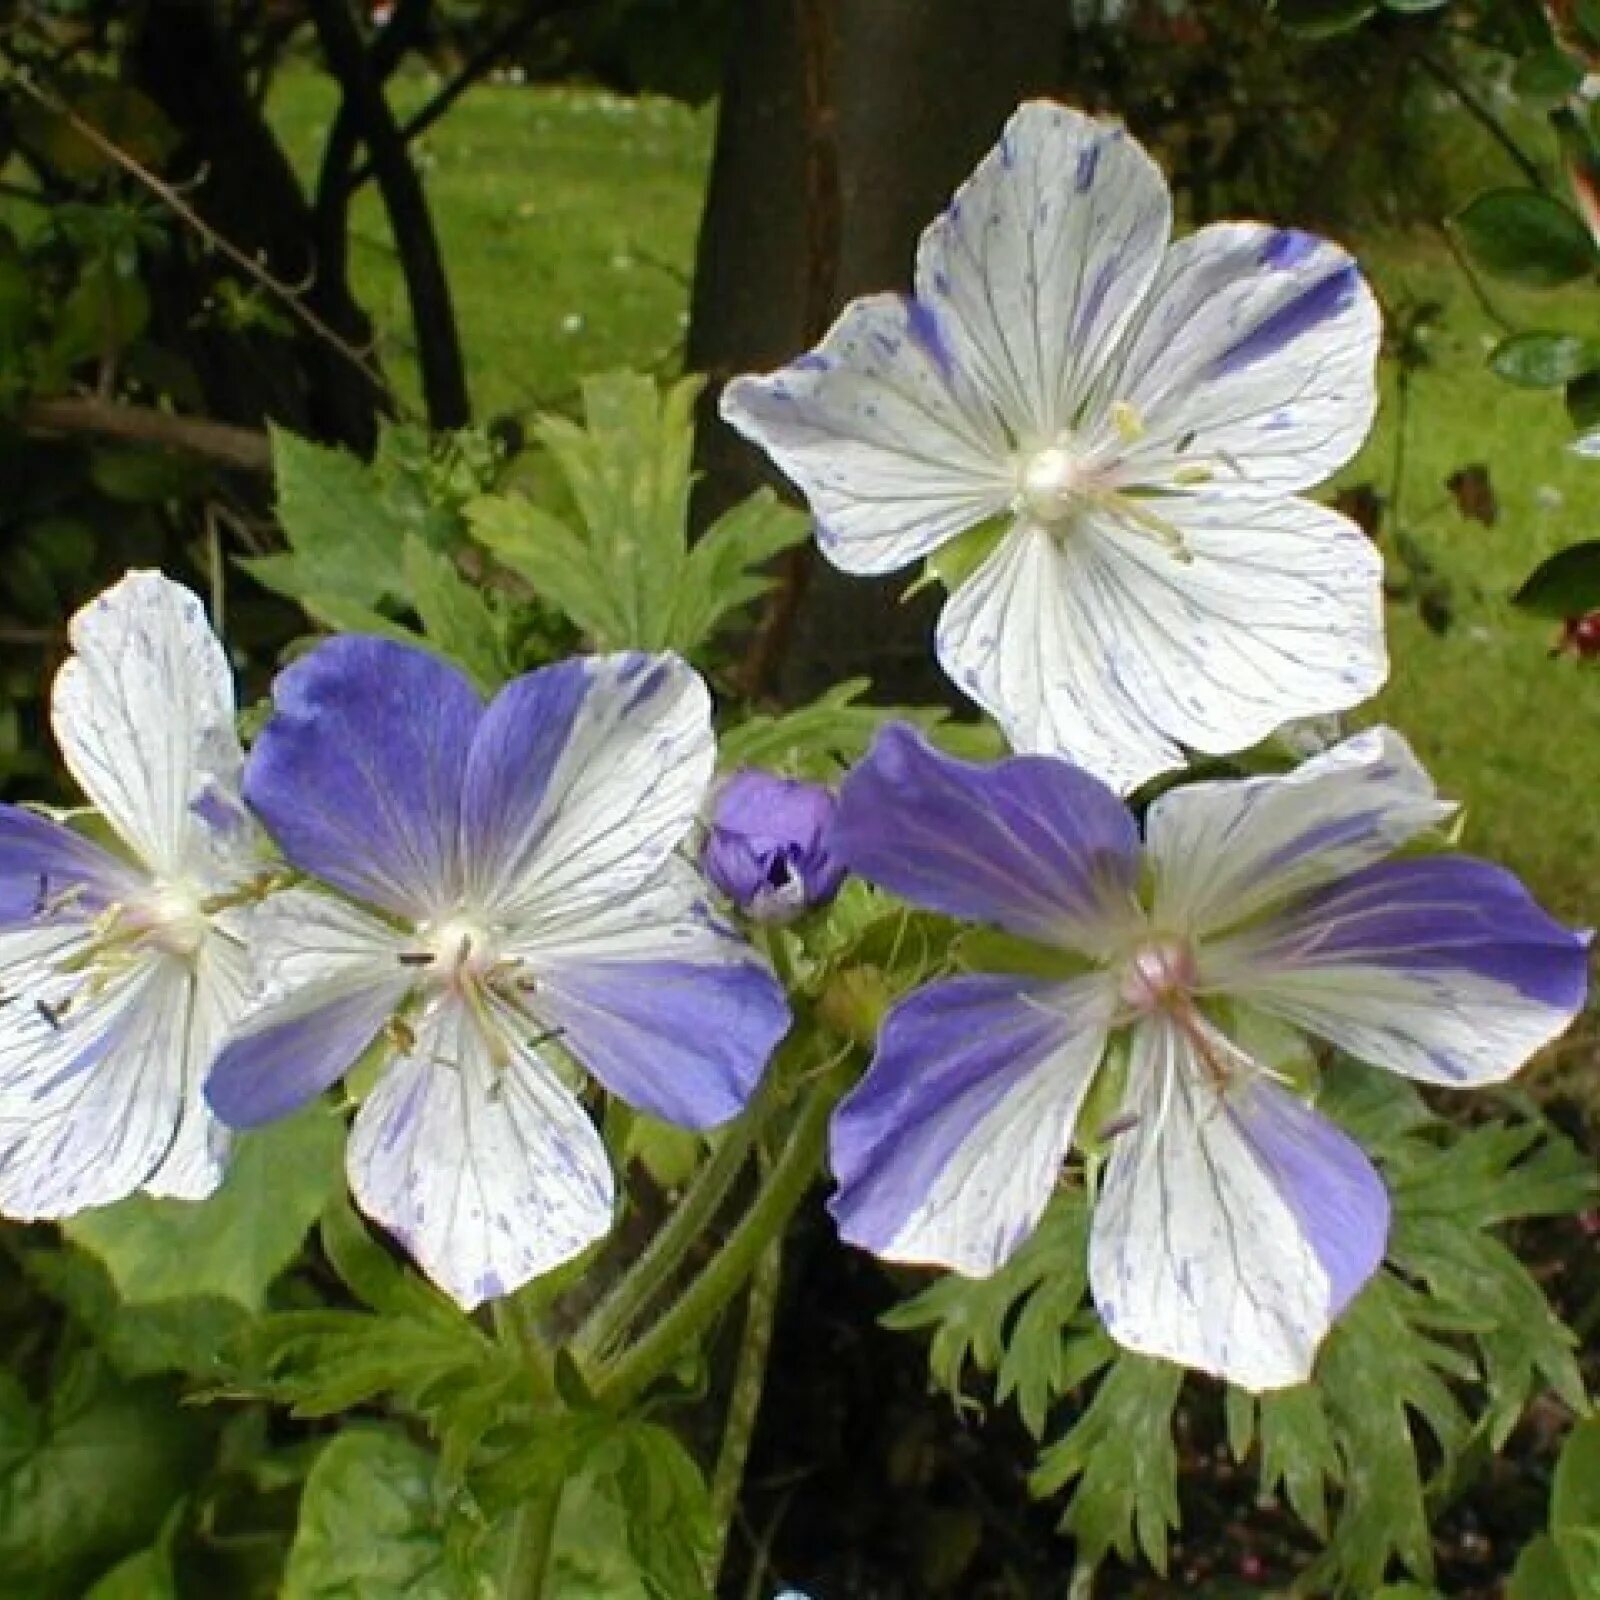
205;984;405;1128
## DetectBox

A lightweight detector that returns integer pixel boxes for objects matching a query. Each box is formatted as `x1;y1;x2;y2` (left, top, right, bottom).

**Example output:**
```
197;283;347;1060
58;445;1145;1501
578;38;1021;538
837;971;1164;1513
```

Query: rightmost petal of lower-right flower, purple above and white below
1202;856;1589;1086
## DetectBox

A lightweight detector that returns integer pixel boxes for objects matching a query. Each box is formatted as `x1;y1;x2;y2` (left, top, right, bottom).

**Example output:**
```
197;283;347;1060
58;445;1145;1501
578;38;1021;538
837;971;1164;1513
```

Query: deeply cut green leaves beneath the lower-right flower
885;1064;1597;1595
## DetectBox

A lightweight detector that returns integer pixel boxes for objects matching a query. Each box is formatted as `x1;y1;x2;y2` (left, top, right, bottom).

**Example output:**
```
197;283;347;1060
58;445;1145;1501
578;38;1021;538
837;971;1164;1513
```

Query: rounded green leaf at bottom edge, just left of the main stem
283;1427;493;1600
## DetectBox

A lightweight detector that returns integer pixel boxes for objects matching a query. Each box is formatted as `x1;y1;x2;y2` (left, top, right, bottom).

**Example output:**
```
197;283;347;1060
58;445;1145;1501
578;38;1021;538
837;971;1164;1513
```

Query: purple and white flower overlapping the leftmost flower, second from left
206;637;789;1307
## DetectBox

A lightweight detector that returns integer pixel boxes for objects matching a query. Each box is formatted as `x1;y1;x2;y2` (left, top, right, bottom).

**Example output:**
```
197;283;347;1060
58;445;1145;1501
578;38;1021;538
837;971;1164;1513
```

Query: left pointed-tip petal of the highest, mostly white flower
722;294;1013;573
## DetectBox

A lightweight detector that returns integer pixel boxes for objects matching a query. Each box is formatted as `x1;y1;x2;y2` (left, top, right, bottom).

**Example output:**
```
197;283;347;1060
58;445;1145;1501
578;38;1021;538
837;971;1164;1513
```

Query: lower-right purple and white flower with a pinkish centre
832;728;1587;1390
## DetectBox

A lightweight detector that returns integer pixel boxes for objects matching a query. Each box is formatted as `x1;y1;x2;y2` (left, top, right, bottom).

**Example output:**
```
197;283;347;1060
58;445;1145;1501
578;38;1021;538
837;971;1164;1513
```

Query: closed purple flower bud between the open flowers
701;770;845;922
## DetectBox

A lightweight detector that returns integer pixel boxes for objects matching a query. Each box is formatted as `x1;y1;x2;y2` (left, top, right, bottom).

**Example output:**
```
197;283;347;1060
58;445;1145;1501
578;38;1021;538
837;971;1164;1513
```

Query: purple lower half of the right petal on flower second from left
536;957;789;1128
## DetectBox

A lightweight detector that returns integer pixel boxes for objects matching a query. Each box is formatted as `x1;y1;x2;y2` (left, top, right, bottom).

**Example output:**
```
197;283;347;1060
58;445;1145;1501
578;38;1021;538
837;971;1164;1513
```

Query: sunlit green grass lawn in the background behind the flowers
274;75;1600;922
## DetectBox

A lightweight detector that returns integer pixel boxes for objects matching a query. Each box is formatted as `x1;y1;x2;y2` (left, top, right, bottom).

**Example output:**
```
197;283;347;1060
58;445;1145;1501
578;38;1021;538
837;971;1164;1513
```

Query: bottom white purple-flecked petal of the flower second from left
349;1003;614;1309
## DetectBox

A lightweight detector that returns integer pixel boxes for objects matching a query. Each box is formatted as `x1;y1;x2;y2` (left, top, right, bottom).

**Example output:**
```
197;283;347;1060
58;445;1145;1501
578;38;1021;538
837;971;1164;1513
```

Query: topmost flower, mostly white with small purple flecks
722;102;1387;790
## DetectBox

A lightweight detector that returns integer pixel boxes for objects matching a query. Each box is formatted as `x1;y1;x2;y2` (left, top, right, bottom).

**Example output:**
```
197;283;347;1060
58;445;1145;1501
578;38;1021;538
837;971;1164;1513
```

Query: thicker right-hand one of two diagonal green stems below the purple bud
592;1067;845;1408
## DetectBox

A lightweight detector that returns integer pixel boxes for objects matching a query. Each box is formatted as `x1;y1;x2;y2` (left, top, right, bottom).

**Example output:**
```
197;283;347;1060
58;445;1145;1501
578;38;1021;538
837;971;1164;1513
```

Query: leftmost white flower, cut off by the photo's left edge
0;573;261;1218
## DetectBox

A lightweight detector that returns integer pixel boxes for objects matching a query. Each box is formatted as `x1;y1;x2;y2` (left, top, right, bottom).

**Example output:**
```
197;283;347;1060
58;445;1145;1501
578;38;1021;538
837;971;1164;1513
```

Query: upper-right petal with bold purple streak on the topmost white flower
1090;222;1382;493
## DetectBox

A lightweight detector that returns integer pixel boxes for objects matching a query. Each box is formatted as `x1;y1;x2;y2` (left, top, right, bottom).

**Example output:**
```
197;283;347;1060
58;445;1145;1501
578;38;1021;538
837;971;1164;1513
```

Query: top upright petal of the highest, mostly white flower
917;101;1171;448
